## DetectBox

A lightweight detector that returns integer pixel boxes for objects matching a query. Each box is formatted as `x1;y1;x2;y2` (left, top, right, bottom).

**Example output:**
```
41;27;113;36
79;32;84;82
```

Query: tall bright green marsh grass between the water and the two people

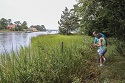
0;35;96;83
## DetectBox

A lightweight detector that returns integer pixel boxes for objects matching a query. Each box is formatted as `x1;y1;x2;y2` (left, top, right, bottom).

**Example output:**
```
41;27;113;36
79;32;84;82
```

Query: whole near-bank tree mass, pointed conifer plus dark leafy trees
58;0;125;38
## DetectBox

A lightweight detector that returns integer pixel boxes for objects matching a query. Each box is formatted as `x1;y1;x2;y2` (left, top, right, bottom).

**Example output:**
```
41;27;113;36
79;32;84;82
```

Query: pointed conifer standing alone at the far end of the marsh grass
58;7;78;35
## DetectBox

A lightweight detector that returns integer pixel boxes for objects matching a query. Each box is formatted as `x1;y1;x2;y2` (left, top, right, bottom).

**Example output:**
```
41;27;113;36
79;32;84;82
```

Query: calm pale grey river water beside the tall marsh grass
0;32;56;54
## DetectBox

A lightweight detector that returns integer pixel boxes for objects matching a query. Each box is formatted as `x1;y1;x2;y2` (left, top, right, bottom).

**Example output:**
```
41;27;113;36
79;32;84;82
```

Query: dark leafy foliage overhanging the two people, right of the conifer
74;0;125;38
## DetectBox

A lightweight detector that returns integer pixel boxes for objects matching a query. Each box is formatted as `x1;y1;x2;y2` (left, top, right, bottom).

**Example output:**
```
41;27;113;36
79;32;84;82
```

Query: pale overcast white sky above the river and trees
0;0;76;29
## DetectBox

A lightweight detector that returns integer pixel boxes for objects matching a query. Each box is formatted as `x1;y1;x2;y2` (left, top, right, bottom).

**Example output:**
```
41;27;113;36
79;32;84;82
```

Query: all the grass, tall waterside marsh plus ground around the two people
0;35;125;83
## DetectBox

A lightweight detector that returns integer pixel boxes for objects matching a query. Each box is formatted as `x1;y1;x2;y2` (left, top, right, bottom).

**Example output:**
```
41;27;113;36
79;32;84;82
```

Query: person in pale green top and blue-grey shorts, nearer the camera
94;33;107;66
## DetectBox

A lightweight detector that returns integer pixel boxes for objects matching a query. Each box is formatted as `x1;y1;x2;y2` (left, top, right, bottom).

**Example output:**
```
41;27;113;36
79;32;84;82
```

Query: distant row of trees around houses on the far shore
0;18;46;31
